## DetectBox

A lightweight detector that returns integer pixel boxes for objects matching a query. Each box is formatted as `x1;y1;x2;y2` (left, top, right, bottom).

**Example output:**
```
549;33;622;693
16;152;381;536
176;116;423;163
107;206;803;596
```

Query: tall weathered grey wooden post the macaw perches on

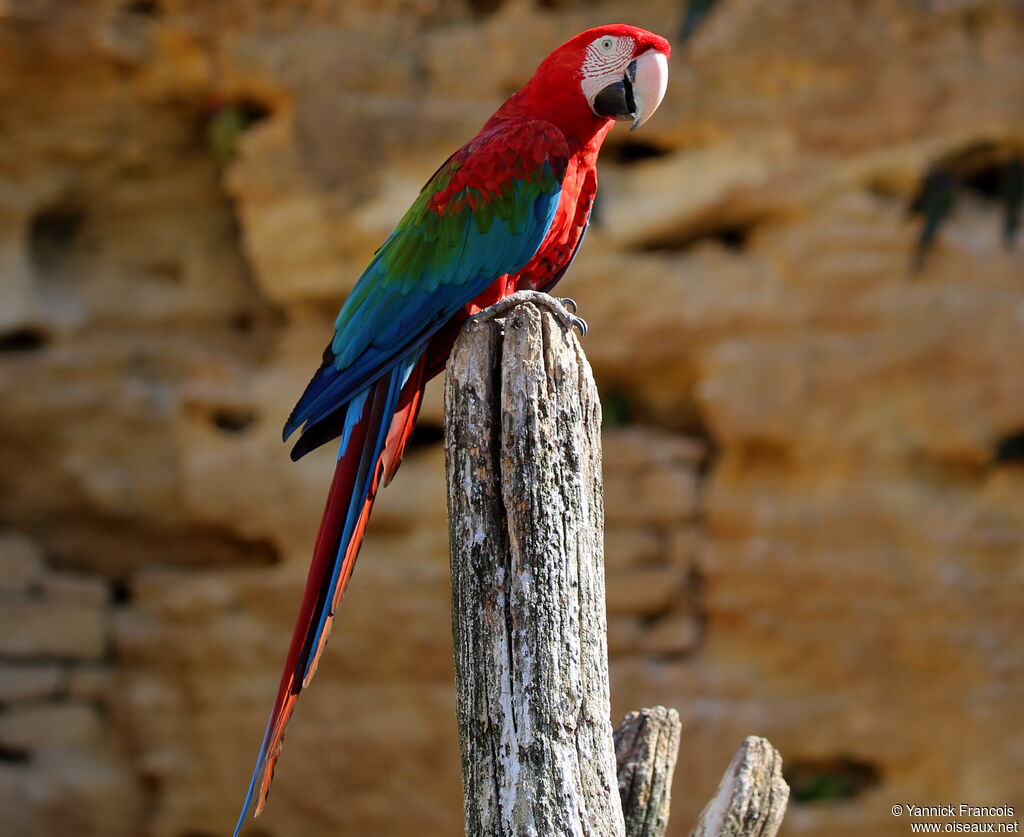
445;303;625;837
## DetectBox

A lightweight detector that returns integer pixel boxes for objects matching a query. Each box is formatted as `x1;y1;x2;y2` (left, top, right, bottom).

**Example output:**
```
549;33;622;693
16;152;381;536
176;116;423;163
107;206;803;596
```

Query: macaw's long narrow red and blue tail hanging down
234;355;429;837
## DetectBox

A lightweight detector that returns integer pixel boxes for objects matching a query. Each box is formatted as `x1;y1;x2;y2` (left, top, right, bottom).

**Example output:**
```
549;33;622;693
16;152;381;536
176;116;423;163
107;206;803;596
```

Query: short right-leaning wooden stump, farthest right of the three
690;736;790;837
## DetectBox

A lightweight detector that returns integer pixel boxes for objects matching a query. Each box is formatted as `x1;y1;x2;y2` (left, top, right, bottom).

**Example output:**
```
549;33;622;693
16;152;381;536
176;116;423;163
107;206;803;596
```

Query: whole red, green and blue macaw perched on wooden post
234;25;671;837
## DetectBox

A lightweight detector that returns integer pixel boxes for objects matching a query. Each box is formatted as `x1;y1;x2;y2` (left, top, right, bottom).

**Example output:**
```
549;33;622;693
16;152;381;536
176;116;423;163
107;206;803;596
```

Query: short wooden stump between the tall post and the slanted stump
615;706;681;837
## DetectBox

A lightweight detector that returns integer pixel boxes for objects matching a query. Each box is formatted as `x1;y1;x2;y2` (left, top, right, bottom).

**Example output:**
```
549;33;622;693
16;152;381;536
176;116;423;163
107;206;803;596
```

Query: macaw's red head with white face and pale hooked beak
505;24;672;140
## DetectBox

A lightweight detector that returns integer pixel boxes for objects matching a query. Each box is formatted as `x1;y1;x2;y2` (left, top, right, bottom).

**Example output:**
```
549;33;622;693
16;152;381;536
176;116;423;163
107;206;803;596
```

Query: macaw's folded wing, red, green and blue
284;120;568;459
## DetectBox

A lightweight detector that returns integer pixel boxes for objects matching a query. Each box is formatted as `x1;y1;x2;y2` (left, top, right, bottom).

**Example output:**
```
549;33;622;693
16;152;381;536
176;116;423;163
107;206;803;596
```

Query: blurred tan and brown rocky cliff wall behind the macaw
0;0;1024;837
